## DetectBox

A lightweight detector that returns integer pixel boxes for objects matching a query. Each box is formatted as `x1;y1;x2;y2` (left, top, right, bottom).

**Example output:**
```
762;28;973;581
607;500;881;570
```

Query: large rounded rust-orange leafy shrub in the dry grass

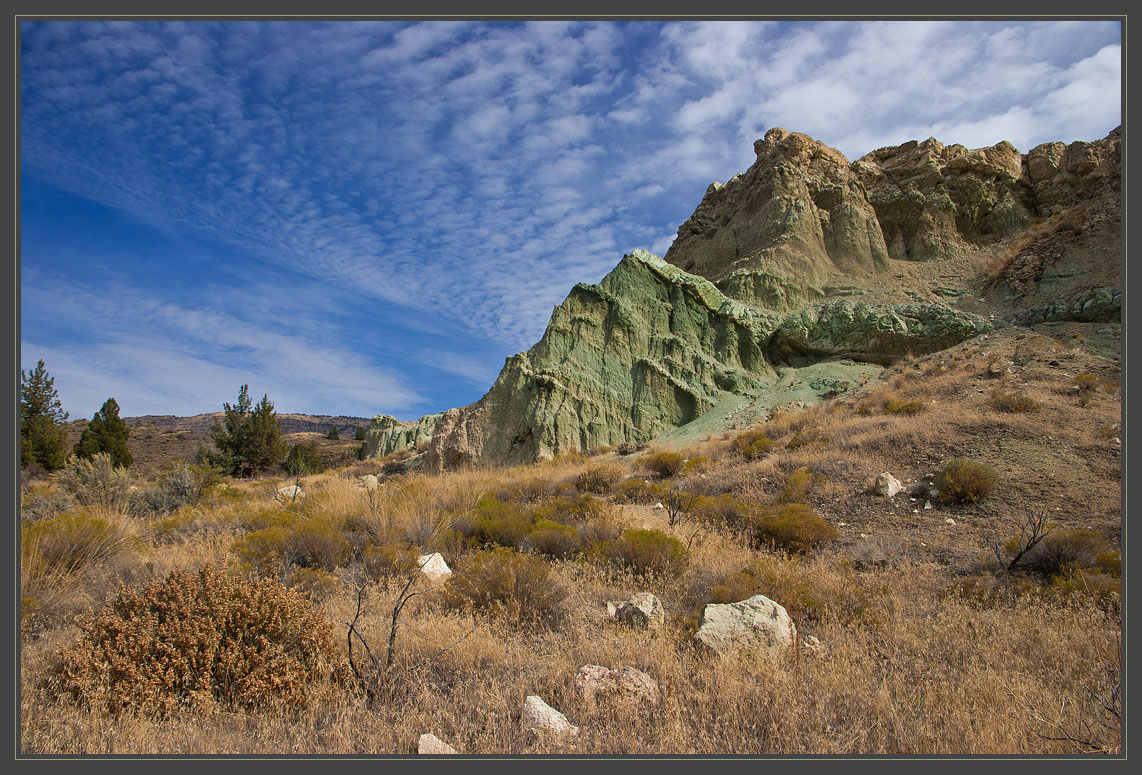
59;566;347;713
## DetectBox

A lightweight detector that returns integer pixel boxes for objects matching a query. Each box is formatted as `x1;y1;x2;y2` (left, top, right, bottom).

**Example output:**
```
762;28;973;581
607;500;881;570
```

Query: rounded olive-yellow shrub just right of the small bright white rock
443;547;566;627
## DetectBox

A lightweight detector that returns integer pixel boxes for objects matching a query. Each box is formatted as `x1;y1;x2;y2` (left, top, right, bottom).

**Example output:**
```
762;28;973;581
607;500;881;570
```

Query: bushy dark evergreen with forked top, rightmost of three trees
210;385;286;476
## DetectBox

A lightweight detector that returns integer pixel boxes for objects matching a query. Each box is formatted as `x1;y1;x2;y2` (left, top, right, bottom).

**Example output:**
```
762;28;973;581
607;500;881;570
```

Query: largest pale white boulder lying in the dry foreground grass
694;595;797;656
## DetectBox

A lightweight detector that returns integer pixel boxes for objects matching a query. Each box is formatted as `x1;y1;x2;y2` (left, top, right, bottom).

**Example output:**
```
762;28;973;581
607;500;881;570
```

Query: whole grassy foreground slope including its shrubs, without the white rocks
21;328;1121;754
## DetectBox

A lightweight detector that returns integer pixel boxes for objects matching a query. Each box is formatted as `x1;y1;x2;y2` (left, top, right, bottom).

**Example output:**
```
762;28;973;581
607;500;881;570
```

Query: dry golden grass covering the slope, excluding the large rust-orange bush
21;326;1121;754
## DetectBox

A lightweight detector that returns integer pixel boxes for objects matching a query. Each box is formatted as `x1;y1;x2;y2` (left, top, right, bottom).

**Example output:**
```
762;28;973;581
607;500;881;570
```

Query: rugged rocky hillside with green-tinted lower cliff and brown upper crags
365;129;1121;471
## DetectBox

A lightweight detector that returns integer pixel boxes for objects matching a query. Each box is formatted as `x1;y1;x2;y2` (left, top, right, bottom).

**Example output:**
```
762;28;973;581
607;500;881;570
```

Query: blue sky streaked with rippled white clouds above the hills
19;21;1121;420
